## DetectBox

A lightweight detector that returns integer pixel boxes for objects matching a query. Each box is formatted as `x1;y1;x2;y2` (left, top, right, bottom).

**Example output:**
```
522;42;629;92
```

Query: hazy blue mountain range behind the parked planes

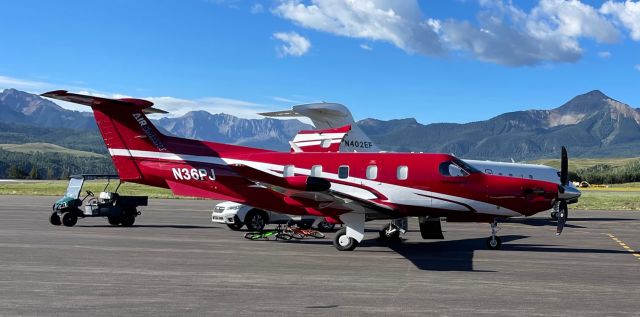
0;89;640;160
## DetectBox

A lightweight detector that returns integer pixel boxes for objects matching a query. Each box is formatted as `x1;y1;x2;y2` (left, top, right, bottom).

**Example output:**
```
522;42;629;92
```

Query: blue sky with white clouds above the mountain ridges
0;0;640;123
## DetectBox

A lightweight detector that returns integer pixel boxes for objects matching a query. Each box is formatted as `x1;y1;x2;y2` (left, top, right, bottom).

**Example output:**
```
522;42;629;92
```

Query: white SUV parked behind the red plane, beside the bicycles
211;201;335;231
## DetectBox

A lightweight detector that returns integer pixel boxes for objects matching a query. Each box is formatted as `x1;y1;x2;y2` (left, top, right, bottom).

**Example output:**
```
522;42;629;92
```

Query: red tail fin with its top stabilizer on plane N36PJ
42;90;167;181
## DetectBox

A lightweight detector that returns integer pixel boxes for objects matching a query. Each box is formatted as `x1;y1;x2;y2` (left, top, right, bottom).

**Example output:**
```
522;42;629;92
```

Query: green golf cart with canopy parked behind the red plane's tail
49;174;148;227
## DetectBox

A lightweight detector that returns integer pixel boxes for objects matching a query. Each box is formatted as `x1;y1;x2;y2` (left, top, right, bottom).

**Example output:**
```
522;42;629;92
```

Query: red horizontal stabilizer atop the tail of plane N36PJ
41;90;168;114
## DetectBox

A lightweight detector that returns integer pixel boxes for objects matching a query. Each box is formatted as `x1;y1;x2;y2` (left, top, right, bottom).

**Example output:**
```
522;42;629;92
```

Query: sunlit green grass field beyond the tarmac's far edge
0;181;640;211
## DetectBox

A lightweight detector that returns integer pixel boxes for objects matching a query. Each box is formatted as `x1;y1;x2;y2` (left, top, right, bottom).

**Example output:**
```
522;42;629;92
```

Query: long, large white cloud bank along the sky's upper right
273;0;624;66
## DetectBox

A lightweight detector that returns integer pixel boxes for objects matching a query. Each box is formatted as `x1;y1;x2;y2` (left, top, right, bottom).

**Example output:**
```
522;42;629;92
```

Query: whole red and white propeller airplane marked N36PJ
42;90;580;251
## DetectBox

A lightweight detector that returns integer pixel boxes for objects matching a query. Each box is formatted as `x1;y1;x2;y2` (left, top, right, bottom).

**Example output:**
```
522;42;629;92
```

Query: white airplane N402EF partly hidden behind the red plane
260;102;561;219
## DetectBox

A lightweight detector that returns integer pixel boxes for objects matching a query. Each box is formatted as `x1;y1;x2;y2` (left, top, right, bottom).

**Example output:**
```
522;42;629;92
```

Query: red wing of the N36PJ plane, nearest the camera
230;164;400;218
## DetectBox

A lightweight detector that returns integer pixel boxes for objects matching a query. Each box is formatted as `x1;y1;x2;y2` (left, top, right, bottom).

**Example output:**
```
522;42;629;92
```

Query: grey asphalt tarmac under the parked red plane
0;196;640;316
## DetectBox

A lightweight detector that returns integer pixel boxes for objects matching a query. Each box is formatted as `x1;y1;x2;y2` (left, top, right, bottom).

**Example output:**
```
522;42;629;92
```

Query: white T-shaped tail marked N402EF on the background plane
261;102;380;152
